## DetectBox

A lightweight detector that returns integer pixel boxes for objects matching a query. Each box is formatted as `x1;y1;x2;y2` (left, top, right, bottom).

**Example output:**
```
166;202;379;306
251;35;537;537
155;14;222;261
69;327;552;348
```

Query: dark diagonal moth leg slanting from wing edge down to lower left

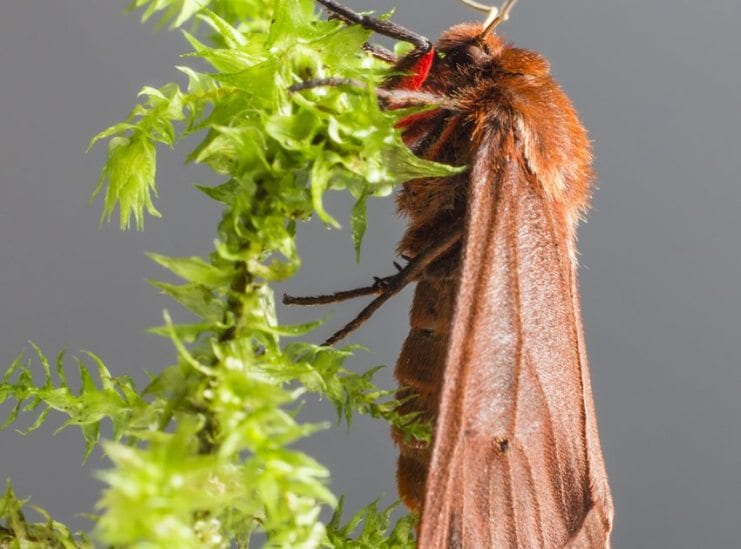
323;229;463;346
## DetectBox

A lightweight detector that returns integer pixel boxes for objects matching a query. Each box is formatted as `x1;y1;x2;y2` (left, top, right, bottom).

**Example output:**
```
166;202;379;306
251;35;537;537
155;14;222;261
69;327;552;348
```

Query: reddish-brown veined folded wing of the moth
419;133;612;549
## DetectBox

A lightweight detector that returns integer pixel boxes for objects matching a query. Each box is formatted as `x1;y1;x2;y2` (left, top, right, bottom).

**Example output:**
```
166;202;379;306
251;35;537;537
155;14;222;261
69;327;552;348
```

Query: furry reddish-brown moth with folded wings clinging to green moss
284;0;613;549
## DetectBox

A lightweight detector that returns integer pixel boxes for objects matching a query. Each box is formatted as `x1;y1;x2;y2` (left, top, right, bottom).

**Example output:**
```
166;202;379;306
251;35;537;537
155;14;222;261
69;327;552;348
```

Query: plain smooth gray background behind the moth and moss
0;0;741;548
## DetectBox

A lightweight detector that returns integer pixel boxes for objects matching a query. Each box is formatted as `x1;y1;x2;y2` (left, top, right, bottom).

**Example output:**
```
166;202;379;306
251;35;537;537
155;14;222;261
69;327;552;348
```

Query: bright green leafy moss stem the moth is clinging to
0;0;457;548
